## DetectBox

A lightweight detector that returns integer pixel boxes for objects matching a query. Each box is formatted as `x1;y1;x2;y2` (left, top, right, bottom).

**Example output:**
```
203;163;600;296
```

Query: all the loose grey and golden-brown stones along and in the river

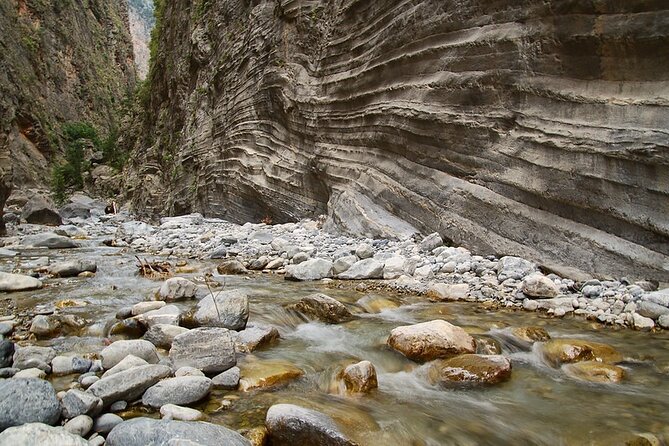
0;196;669;445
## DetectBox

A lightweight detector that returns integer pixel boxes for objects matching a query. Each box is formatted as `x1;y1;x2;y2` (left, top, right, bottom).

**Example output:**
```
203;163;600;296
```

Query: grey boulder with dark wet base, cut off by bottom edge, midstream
265;404;356;446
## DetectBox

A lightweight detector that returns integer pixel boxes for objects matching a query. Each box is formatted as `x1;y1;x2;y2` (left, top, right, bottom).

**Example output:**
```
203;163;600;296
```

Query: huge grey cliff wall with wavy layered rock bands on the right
129;0;669;281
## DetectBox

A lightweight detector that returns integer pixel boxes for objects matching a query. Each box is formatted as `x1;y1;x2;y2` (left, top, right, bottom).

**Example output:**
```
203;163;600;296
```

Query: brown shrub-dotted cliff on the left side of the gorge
0;0;135;230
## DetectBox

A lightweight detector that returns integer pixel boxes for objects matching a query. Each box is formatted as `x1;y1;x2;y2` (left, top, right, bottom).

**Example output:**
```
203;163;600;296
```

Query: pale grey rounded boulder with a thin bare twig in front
193;290;249;330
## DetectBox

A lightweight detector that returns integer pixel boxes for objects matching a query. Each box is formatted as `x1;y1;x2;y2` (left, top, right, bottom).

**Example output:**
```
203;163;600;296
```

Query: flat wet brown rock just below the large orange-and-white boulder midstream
428;354;511;386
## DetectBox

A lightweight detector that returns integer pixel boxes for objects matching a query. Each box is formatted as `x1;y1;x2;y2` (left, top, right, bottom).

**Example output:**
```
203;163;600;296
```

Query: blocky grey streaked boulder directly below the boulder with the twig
170;327;237;373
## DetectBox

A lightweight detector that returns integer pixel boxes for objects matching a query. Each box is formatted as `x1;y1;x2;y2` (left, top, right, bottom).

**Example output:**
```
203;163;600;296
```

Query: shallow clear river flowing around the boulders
0;240;669;445
